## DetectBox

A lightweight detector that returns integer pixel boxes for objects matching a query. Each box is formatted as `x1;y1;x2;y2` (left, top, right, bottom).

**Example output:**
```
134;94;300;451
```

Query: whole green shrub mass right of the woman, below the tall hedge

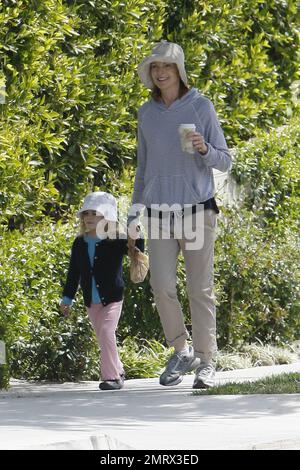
216;119;300;347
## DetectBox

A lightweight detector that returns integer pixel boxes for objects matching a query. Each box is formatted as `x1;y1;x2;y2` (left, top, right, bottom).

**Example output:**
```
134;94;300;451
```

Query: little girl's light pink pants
87;300;124;380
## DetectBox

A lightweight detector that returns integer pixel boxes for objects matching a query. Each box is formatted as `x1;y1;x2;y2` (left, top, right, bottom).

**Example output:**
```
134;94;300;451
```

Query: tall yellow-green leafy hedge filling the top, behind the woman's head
0;0;299;227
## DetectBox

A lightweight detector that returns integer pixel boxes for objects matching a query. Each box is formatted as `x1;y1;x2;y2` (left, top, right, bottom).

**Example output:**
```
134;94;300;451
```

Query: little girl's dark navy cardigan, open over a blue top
63;236;144;307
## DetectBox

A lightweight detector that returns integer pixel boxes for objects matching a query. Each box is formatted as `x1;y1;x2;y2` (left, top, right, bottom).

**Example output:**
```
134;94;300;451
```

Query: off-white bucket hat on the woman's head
138;41;188;90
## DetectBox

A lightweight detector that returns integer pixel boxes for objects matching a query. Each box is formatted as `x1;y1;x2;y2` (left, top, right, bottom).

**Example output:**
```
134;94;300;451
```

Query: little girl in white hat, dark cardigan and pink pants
60;191;144;390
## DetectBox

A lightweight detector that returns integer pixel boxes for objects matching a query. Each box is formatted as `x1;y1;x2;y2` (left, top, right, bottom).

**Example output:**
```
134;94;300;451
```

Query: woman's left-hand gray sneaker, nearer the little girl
159;346;200;385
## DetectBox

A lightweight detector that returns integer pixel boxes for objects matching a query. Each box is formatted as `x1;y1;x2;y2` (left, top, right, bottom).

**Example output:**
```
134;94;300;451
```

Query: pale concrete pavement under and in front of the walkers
0;363;300;450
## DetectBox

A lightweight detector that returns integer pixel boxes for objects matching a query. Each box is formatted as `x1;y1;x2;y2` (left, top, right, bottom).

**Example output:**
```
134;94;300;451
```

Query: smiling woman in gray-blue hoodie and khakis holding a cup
132;41;231;388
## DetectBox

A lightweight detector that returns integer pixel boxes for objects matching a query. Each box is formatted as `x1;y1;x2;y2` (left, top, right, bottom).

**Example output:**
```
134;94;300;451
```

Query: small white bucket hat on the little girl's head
77;191;118;222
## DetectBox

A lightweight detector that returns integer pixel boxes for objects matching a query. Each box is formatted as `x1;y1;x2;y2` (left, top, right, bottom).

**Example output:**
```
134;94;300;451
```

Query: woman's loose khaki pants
148;209;217;362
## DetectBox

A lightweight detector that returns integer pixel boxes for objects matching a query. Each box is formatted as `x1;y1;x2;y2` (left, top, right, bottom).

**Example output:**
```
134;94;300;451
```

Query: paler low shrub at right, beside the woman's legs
216;208;300;347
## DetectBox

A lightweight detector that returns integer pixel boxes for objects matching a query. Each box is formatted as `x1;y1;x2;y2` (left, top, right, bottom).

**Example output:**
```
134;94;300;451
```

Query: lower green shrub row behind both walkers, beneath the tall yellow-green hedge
0;116;300;379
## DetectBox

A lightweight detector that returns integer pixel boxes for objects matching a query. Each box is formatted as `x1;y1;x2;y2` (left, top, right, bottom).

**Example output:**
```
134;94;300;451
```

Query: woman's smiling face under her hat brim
150;62;180;93
